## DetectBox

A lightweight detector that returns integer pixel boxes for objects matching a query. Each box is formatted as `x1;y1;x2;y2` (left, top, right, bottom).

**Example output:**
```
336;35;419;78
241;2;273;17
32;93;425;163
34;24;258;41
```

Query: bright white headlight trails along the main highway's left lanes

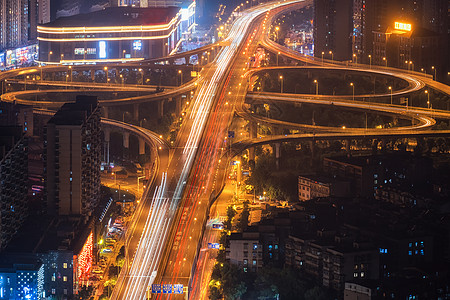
111;0;306;300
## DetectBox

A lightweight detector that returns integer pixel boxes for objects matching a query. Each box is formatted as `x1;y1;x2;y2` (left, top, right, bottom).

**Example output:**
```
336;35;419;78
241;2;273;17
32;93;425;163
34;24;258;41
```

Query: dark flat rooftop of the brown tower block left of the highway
48;95;98;125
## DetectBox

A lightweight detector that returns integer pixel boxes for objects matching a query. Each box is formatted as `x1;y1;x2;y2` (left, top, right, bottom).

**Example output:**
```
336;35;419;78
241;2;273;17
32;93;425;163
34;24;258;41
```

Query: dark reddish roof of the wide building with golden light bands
43;6;180;28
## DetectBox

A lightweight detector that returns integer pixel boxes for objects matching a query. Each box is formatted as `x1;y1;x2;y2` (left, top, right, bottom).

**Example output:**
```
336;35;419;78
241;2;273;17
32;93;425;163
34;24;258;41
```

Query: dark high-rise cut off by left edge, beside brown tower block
0;126;28;249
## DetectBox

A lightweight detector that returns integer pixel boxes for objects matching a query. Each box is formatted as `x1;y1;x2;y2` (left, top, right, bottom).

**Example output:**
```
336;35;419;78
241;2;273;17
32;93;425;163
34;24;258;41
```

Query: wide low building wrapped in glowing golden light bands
38;7;182;64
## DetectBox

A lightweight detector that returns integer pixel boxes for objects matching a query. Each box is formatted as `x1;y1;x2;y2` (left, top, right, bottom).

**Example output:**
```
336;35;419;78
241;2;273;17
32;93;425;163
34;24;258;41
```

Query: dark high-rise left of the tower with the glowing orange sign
314;0;352;60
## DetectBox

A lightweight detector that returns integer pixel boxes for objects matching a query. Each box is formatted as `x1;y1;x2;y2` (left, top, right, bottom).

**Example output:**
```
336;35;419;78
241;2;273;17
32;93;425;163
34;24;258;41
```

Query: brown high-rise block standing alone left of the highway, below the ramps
45;96;101;219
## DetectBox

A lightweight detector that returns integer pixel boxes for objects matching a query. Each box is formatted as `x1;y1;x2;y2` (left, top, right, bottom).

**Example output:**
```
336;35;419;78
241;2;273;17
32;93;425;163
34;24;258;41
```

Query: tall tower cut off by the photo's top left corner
0;0;29;49
